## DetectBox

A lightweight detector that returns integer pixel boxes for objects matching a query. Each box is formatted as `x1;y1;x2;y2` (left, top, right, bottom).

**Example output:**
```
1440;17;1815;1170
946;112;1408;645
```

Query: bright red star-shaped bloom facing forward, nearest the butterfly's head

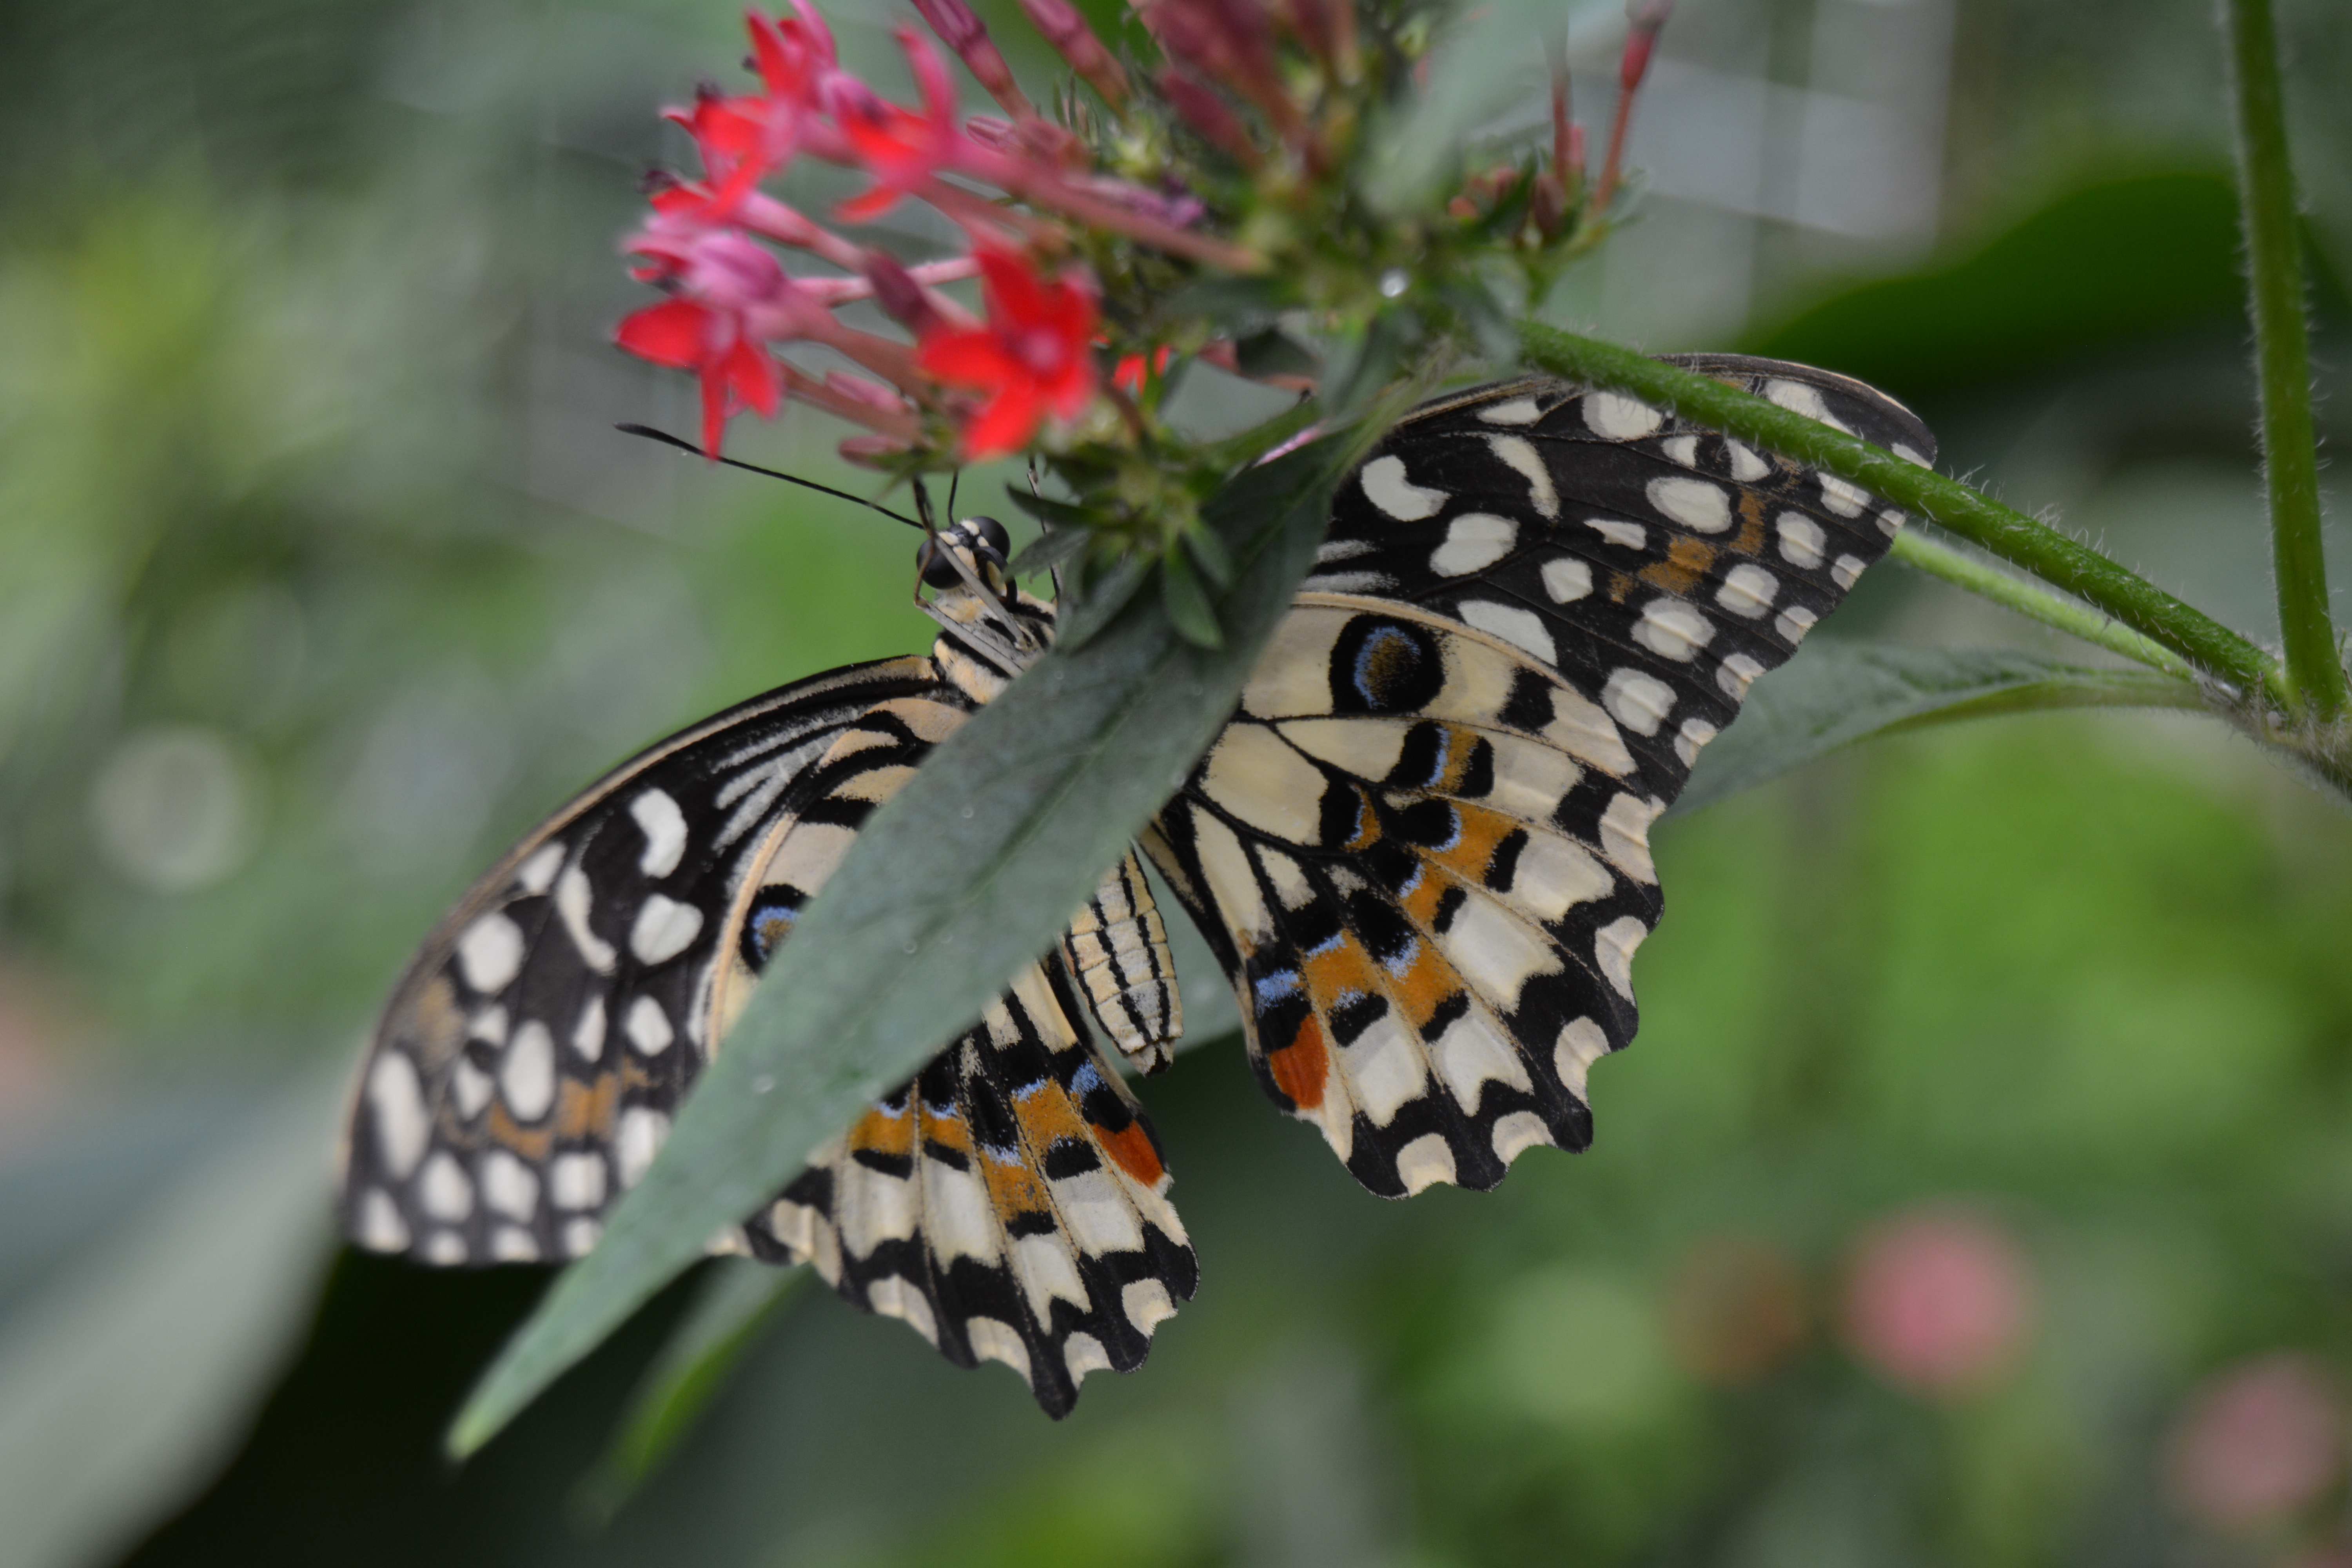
915;249;1096;461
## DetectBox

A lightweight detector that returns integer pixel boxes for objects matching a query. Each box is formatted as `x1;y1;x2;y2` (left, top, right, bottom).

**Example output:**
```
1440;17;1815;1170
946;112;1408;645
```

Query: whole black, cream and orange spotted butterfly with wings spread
341;355;1936;1415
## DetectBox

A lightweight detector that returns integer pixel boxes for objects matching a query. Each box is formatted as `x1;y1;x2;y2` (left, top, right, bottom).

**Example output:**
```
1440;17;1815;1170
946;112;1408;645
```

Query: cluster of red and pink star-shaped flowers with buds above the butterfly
619;0;1665;576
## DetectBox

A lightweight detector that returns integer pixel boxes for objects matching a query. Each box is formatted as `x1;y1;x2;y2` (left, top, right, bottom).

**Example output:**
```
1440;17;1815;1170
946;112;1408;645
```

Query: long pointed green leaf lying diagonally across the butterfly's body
449;416;1409;1455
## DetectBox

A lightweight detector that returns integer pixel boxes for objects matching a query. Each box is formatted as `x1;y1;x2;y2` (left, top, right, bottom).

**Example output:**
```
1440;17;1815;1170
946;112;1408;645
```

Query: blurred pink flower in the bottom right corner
2171;1354;2345;1526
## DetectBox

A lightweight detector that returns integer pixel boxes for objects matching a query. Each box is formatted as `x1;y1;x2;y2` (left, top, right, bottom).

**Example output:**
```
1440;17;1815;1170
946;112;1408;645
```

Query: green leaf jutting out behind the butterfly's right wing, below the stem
1668;642;2206;816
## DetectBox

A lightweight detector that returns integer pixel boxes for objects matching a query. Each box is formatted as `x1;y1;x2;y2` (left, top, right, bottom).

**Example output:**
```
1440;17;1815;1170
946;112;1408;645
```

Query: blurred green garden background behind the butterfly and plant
0;0;2352;1568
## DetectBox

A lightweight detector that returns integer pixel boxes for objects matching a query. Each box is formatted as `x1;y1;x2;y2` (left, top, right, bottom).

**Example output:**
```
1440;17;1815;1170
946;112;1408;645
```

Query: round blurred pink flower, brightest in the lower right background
1844;1208;2032;1396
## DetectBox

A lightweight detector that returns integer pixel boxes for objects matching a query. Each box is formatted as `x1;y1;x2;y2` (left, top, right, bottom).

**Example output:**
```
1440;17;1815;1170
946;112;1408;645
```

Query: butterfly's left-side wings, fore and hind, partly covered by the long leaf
343;658;1195;1413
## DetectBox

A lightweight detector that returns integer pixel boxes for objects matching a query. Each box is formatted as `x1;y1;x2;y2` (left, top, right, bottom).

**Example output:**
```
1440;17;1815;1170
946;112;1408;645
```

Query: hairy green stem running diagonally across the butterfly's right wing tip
1519;322;2286;701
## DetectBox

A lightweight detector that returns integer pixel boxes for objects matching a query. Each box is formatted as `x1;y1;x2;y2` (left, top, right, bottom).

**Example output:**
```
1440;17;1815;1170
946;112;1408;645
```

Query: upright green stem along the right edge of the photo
2223;0;2347;719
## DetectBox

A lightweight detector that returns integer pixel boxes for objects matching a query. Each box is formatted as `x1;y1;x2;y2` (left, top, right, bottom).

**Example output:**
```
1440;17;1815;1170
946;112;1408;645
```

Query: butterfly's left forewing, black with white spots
343;658;946;1265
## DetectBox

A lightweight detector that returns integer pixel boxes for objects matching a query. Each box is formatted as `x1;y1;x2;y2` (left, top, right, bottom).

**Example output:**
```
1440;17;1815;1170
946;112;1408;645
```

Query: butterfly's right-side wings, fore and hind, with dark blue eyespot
1145;355;1933;1196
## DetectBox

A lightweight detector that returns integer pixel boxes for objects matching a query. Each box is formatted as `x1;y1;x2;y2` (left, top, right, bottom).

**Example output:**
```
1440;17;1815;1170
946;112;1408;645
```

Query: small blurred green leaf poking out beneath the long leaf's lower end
572;1258;809;1526
